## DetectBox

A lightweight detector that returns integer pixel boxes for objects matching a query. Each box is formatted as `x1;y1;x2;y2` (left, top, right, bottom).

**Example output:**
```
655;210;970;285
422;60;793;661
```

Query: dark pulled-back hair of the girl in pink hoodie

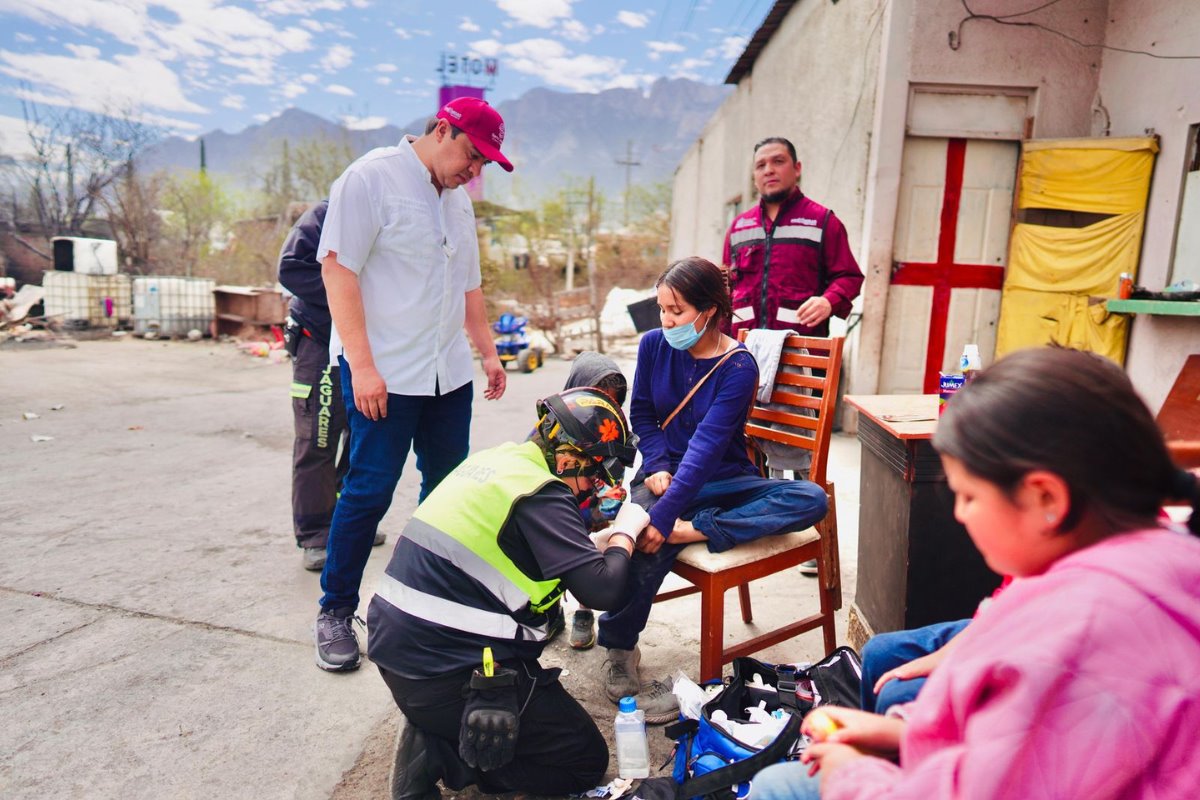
934;347;1200;533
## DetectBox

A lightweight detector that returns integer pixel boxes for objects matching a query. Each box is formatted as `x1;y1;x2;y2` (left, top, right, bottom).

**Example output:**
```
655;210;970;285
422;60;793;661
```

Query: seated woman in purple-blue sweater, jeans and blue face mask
599;257;827;722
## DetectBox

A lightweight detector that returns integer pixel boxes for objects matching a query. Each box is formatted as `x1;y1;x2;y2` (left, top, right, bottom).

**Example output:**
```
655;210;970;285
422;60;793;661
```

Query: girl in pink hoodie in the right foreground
750;348;1200;800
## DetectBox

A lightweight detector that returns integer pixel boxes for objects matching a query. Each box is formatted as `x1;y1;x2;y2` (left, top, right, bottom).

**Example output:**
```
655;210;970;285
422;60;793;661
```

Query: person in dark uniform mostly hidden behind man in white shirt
280;200;388;572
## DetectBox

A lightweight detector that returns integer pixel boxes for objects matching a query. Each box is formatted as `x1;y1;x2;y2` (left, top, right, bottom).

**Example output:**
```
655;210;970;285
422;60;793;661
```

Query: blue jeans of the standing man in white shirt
320;359;474;610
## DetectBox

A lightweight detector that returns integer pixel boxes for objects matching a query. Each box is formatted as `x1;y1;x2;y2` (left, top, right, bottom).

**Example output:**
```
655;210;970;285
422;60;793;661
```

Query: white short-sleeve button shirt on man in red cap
317;139;480;396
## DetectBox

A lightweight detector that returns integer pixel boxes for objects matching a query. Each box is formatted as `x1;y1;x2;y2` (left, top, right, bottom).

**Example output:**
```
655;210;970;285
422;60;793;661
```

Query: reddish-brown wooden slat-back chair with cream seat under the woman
654;332;844;680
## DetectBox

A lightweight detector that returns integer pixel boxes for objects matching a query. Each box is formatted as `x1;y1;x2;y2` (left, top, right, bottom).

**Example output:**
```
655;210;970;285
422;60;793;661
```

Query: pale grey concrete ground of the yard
0;338;858;800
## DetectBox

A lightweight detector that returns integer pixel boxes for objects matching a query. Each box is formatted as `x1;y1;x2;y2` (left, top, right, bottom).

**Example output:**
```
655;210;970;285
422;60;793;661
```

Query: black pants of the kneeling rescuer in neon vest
379;661;608;796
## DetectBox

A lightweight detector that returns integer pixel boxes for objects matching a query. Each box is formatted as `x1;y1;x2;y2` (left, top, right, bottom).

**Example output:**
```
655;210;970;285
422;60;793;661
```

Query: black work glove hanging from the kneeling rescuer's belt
458;667;521;771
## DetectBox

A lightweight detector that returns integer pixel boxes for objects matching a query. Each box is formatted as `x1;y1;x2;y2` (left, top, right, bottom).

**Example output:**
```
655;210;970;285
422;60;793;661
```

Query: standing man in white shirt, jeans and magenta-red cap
316;97;512;672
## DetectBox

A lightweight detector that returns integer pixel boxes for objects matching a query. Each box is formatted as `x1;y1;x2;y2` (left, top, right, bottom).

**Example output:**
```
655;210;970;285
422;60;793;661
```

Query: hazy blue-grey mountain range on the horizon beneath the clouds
142;78;730;207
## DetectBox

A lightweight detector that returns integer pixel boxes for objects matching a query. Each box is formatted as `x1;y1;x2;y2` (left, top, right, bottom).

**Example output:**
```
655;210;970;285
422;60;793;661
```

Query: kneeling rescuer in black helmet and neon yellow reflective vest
367;387;649;800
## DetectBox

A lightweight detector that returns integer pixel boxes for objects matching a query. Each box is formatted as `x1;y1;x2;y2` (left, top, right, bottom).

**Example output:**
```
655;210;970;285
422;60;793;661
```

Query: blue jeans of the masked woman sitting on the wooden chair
599;475;829;650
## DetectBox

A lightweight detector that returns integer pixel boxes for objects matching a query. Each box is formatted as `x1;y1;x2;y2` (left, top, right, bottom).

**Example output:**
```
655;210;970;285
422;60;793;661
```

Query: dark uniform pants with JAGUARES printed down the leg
292;335;349;547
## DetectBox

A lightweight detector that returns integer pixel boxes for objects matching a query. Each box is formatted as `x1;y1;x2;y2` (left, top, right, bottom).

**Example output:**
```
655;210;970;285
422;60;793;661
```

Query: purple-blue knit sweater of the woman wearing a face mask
629;330;758;536
